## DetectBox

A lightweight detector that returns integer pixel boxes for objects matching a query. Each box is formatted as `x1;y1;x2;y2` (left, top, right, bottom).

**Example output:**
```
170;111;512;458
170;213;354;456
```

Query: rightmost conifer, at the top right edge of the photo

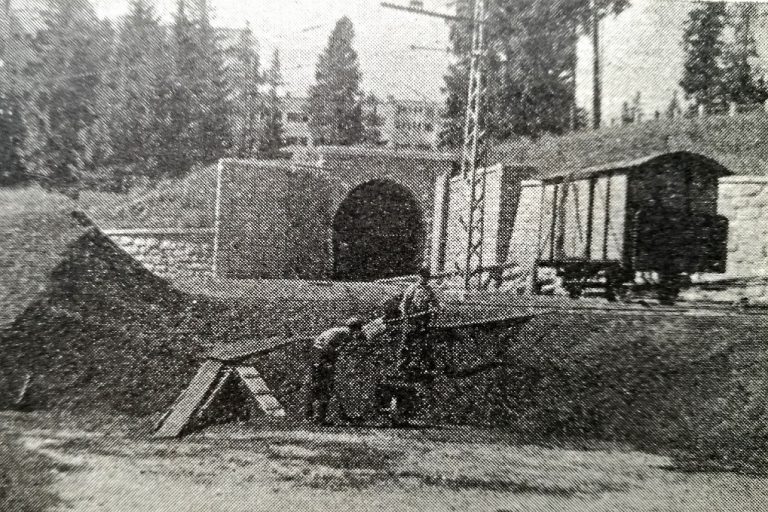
723;4;768;105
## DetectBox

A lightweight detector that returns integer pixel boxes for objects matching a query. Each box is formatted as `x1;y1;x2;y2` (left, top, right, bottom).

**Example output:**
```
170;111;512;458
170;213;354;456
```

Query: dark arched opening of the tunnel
333;180;424;281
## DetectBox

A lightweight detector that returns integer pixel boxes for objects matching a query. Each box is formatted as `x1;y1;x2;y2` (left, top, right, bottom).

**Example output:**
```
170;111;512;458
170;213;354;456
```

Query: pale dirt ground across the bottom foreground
0;413;768;512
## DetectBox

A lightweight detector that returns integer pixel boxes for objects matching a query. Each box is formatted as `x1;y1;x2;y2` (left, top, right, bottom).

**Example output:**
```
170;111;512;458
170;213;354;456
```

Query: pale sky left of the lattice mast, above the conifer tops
92;0;451;101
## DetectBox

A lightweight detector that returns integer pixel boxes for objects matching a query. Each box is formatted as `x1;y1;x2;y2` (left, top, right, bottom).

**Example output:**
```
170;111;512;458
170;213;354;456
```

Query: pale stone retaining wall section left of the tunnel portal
104;228;214;279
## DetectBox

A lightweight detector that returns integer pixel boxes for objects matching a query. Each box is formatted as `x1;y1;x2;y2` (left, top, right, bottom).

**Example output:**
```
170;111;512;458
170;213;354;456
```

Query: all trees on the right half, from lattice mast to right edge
441;0;768;146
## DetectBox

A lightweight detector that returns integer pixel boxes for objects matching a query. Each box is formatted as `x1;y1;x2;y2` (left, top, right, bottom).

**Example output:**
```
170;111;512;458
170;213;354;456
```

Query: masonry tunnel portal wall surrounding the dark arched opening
214;146;456;280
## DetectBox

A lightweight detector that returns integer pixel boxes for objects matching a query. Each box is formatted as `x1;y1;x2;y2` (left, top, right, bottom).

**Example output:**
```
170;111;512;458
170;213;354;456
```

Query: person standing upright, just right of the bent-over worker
398;268;440;380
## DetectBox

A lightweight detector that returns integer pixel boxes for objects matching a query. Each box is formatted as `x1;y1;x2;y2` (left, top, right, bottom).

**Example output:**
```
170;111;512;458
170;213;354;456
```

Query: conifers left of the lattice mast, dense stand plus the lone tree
0;0;380;195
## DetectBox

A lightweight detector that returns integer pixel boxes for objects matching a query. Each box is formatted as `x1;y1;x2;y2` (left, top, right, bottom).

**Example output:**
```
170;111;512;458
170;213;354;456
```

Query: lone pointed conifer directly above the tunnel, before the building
308;16;365;145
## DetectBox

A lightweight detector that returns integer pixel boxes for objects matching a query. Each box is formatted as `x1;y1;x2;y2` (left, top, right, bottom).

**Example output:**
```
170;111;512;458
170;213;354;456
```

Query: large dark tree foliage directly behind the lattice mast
440;0;628;146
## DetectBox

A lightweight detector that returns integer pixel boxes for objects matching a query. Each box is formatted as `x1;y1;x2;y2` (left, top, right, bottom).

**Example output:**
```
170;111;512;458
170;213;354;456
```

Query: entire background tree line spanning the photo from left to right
0;0;768;193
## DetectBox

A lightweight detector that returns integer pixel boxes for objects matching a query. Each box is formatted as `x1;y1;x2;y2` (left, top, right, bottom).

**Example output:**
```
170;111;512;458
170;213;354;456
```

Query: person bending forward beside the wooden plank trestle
304;317;365;425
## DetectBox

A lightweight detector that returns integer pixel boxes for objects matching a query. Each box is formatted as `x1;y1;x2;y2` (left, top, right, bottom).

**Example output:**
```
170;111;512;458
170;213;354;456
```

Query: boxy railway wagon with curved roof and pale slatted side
538;152;729;302
